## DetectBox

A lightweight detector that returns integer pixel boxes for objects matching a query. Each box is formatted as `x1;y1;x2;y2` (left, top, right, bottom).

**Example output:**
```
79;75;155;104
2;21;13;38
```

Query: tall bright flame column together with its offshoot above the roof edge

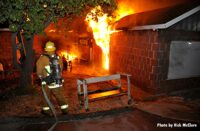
85;6;134;70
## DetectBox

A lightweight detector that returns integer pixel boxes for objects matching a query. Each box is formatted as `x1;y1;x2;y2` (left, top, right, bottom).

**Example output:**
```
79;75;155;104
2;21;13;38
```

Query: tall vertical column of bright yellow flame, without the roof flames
86;6;110;70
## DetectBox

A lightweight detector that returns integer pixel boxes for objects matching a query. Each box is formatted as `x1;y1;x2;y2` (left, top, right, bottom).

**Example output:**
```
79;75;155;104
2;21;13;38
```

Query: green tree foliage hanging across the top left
0;0;115;38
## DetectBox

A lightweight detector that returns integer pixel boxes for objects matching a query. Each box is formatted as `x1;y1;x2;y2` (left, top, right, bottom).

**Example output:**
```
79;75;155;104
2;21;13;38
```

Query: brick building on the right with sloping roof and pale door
110;1;200;94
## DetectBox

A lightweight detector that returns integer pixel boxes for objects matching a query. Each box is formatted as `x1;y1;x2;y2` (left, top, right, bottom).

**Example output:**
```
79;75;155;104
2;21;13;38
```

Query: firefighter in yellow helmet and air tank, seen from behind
36;41;68;115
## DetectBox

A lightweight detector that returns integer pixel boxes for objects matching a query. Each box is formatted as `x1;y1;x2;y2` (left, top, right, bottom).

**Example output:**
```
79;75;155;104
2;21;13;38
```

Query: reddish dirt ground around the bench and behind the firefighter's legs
0;65;148;118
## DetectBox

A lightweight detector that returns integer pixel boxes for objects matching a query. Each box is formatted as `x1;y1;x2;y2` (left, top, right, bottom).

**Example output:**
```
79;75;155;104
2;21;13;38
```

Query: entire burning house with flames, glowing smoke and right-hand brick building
0;2;200;93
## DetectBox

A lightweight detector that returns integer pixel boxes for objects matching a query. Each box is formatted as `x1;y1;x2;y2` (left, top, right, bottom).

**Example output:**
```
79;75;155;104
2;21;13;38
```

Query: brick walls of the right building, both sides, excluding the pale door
110;30;200;93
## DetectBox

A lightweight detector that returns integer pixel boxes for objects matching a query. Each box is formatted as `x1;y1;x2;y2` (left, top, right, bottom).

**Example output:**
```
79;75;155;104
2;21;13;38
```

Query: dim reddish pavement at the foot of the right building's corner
135;97;200;122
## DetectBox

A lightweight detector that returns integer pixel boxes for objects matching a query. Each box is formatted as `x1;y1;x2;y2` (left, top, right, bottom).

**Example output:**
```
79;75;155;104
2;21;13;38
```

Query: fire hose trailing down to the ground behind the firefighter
41;83;58;131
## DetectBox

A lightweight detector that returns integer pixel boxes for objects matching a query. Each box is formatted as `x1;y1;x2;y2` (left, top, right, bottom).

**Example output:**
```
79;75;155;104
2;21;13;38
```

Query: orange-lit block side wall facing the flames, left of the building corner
110;31;159;92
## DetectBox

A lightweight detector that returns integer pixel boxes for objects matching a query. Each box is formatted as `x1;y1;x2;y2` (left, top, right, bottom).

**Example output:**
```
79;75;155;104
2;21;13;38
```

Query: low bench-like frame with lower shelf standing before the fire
77;74;132;111
